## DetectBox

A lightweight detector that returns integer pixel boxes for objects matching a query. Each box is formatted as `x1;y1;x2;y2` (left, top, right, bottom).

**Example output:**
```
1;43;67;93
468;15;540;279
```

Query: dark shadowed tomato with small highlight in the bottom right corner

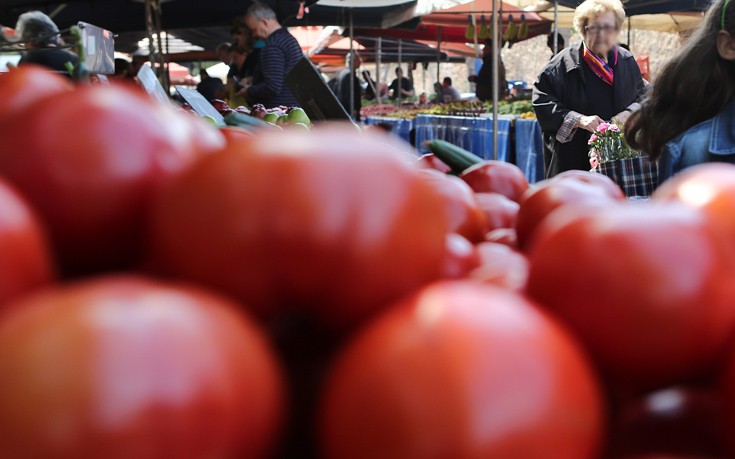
609;387;724;457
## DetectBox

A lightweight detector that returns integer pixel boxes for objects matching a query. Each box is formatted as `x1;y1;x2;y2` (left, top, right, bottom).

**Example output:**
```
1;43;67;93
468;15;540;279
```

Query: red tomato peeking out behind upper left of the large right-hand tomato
516;179;625;252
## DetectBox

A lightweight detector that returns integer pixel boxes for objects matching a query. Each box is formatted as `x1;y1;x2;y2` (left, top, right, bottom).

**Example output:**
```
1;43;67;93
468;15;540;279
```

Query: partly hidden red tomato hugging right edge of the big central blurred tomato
423;170;486;242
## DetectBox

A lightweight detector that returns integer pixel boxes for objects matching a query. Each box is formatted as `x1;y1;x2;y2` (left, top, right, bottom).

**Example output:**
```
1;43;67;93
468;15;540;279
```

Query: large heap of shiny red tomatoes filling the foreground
0;67;735;459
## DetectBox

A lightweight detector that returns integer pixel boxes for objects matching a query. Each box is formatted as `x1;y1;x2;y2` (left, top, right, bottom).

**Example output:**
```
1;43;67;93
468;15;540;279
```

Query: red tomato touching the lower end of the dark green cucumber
460;161;528;202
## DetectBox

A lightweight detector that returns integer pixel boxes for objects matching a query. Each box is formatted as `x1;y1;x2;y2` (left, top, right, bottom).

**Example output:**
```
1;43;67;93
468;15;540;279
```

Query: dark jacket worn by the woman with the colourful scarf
533;43;645;177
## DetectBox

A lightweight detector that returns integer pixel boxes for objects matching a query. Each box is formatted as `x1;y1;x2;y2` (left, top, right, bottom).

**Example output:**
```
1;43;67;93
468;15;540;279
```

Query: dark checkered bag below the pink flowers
592;156;658;197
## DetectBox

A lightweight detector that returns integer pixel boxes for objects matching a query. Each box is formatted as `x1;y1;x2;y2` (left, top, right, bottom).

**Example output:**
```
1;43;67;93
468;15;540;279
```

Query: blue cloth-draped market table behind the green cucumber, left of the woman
414;115;513;161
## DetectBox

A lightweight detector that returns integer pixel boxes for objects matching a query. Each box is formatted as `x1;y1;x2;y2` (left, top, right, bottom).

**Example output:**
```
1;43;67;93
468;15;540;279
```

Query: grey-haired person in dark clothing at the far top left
15;11;79;76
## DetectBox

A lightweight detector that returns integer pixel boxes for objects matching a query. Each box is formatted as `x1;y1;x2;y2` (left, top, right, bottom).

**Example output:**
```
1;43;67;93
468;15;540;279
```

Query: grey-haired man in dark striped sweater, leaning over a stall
243;3;304;108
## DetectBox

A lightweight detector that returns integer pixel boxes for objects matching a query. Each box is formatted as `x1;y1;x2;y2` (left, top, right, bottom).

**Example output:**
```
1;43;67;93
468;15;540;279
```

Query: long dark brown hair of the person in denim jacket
625;0;735;159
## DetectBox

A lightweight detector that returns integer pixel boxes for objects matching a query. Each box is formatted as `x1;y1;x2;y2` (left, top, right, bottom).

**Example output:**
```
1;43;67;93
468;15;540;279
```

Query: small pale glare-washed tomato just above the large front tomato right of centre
469;242;529;292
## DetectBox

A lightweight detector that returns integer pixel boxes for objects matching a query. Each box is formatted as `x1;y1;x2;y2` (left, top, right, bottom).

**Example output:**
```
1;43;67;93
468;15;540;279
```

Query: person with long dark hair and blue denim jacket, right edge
625;0;735;182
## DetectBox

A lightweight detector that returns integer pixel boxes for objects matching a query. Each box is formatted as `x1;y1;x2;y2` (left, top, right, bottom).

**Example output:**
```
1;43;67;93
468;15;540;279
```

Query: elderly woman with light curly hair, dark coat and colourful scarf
533;0;645;177
